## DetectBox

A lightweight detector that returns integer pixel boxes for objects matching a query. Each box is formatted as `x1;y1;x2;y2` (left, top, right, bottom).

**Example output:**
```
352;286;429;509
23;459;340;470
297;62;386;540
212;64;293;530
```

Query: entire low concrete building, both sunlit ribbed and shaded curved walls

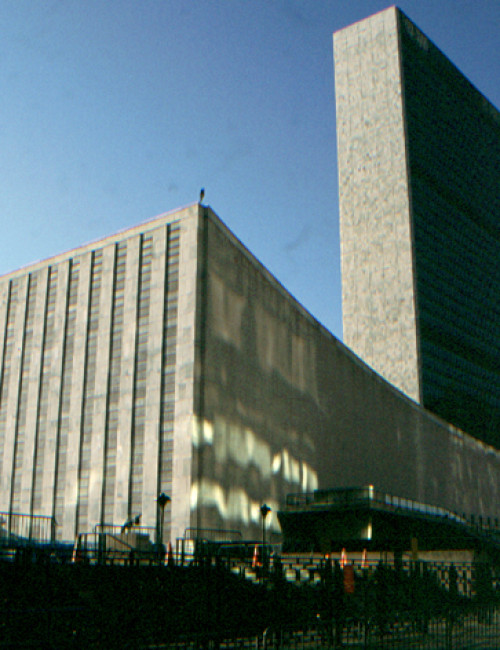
0;200;500;540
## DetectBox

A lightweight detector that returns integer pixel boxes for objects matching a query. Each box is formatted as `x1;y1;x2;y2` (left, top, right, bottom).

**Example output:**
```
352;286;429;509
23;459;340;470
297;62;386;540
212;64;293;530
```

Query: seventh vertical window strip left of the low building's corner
10;273;38;512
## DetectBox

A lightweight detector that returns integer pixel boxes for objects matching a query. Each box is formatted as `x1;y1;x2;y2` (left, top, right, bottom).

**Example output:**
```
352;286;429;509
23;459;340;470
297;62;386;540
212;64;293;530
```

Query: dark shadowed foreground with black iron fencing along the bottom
0;533;500;650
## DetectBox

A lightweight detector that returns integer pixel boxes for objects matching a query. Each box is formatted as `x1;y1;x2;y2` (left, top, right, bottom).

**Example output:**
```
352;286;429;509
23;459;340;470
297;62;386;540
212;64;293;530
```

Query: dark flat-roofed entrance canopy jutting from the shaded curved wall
278;486;500;554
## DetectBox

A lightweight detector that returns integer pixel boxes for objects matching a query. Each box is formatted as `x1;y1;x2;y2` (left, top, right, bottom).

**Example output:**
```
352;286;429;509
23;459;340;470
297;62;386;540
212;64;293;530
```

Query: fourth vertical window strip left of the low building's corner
77;250;102;532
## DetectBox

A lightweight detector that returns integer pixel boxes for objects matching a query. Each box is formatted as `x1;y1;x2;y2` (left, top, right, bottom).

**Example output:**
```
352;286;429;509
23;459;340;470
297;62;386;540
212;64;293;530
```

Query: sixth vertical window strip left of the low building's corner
31;266;58;514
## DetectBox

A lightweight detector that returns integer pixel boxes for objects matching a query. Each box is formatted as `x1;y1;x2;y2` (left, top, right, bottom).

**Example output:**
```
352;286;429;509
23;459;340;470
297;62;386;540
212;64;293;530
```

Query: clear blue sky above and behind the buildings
0;0;500;338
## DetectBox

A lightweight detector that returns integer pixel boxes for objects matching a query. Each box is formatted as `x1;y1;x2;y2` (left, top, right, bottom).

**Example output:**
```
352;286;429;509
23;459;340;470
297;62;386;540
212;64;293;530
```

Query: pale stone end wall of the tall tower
334;7;420;402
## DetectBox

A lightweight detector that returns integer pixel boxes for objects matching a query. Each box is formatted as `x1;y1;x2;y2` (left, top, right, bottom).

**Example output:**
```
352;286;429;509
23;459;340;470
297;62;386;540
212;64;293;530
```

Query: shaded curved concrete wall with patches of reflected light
191;206;500;538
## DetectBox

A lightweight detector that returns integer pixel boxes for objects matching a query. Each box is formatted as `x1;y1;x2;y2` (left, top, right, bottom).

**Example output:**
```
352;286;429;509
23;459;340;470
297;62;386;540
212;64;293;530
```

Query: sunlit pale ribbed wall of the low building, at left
0;205;199;540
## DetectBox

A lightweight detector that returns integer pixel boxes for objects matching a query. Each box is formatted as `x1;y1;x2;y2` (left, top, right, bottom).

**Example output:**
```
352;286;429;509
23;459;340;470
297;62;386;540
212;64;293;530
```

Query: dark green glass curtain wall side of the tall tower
399;14;500;447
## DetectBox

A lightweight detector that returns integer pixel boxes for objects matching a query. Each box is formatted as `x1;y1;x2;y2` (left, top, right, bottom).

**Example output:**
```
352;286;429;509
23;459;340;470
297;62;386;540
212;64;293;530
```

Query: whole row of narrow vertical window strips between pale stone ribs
0;227;179;529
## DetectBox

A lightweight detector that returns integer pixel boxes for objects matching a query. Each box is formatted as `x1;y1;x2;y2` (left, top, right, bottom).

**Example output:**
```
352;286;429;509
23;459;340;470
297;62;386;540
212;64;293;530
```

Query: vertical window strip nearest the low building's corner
158;225;180;539
